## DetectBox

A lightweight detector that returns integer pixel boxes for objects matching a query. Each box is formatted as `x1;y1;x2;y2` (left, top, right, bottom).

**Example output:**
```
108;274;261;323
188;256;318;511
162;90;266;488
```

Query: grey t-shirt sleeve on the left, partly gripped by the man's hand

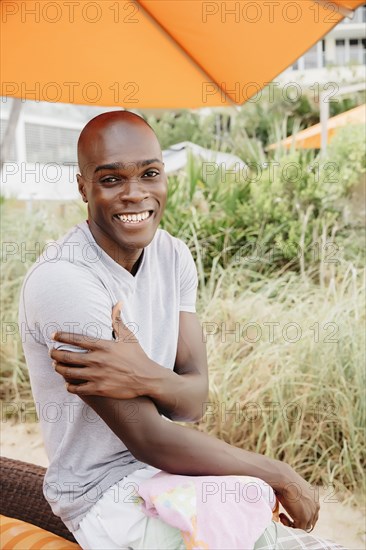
19;261;113;352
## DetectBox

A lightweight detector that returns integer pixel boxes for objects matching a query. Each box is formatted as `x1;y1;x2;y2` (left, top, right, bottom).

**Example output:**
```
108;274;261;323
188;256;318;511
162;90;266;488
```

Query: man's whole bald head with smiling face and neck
77;111;167;271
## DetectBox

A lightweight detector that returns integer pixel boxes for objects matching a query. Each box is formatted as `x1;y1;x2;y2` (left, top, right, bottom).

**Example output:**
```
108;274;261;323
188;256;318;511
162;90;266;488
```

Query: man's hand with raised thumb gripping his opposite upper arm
50;302;163;399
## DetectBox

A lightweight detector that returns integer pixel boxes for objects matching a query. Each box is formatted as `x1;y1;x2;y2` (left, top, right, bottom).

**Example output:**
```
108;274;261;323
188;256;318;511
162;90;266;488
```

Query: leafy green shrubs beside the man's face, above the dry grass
162;126;365;280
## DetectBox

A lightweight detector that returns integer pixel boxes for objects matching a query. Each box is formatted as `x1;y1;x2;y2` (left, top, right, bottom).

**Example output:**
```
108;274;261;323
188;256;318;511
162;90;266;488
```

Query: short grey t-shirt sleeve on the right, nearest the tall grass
179;241;198;313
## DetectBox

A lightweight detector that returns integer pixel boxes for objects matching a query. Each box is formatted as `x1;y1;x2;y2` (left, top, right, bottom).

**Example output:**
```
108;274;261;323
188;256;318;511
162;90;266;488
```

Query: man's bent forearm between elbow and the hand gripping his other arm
146;362;208;422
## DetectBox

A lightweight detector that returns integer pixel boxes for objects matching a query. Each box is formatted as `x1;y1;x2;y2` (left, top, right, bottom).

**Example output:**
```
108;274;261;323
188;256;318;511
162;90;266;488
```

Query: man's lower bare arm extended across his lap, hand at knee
79;396;319;529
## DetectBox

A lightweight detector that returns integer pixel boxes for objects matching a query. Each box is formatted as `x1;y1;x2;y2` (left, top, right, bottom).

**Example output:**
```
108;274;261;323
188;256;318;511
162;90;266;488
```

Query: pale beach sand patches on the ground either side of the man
0;420;366;550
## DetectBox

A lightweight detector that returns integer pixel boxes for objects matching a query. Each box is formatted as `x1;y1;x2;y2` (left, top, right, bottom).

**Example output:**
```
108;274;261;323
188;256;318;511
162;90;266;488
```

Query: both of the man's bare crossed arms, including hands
51;312;319;529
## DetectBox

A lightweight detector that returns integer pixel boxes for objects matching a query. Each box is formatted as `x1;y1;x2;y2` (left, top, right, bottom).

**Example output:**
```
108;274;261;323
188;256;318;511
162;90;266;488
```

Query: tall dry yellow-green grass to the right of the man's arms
193;258;366;500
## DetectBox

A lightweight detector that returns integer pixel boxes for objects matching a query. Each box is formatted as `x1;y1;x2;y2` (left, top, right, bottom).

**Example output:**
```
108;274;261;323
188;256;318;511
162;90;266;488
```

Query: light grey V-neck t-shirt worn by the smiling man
19;222;198;531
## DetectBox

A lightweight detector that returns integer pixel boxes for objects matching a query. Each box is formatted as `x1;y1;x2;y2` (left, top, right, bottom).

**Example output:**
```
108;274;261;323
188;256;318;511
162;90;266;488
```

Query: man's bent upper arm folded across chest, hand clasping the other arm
51;306;208;421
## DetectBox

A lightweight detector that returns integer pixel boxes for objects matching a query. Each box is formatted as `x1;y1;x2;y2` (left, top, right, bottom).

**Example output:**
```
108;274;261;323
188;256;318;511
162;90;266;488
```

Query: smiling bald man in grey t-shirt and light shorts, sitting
19;111;346;550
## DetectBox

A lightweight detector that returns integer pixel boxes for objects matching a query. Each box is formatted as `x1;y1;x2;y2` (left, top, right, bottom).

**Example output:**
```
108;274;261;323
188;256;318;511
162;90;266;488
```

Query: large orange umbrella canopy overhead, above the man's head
0;0;363;109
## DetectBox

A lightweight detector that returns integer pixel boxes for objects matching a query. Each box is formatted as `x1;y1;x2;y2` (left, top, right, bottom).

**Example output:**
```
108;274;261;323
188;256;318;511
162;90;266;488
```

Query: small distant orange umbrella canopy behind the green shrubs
268;104;366;149
